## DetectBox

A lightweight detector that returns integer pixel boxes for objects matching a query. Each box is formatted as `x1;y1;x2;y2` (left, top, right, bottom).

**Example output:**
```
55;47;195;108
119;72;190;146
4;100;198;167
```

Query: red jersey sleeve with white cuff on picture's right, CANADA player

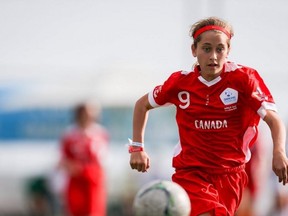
248;70;277;119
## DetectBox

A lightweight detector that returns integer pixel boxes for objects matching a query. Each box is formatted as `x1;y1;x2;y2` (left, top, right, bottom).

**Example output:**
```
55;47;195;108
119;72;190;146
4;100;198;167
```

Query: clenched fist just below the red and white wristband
130;151;150;172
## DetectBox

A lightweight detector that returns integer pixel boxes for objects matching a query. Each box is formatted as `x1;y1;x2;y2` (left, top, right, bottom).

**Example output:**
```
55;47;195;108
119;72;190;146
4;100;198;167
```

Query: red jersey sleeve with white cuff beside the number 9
148;72;181;107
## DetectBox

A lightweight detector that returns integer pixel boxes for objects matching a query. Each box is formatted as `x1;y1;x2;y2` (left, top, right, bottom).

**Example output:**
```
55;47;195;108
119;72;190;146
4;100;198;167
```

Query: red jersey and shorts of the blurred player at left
61;124;108;216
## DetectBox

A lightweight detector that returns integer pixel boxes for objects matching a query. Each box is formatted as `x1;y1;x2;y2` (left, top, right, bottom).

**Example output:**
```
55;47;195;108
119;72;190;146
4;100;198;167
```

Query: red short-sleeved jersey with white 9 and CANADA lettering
148;62;276;169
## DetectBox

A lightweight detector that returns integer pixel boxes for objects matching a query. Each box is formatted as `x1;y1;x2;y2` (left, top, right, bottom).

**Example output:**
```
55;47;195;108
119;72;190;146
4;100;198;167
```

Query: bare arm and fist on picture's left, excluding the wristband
130;94;153;172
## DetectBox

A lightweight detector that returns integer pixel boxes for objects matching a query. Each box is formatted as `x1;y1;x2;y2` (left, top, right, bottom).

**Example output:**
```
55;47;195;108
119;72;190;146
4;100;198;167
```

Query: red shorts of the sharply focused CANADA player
172;165;248;216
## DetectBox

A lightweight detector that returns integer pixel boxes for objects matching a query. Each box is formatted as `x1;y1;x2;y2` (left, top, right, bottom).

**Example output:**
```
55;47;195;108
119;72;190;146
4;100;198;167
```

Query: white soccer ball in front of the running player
133;180;191;216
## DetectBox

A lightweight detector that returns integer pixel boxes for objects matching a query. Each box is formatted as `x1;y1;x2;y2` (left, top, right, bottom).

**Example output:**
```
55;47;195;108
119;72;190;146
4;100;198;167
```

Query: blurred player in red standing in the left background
60;103;109;216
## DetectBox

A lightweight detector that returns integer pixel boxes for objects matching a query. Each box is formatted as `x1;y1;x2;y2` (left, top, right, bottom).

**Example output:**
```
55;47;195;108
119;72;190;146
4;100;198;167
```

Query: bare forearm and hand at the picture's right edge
263;110;288;185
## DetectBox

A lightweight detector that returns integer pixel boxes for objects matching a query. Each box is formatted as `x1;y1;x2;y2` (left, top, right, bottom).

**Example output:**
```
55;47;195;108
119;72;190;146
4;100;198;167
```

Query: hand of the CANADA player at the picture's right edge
272;153;288;185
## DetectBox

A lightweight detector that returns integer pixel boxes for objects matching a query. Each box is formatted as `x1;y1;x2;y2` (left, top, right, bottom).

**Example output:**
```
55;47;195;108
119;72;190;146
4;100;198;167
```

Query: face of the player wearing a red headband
192;31;229;81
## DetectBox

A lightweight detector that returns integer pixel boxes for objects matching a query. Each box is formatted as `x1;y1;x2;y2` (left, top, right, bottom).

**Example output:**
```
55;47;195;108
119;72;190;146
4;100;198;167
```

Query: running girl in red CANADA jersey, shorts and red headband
129;17;288;216
